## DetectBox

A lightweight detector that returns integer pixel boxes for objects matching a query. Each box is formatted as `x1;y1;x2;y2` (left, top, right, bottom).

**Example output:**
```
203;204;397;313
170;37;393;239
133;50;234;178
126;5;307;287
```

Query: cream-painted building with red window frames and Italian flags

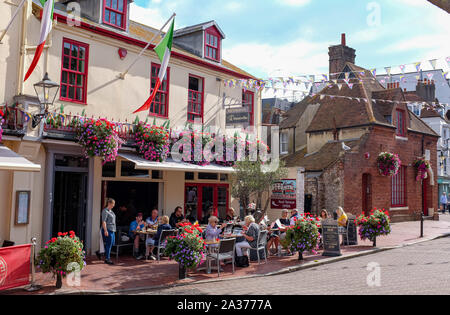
0;0;261;253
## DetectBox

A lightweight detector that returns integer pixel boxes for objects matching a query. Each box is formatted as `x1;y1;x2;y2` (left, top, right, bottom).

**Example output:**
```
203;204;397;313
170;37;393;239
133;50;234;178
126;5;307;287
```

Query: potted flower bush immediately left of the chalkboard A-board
281;213;320;260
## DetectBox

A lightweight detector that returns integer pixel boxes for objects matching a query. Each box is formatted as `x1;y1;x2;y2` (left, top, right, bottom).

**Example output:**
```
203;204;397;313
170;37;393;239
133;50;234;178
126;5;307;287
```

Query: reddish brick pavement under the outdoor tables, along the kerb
2;215;450;294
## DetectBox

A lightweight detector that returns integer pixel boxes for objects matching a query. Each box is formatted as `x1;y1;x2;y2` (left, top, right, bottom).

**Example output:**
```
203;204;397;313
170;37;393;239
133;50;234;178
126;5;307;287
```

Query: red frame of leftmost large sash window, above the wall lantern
59;38;89;105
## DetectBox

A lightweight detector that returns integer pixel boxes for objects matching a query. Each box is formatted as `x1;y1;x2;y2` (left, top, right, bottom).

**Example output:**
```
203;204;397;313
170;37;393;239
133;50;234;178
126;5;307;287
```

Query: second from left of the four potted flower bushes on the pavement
165;223;206;279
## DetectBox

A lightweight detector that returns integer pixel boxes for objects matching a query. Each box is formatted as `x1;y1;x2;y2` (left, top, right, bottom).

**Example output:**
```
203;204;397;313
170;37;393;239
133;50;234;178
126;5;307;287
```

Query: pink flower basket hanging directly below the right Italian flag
135;123;169;162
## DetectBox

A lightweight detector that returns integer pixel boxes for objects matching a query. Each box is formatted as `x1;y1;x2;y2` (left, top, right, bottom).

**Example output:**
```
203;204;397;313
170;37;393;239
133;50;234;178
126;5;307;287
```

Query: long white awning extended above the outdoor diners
119;153;234;174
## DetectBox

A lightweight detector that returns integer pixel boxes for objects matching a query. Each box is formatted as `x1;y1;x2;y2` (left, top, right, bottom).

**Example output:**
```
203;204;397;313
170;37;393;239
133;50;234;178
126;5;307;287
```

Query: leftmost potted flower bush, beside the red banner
36;231;86;289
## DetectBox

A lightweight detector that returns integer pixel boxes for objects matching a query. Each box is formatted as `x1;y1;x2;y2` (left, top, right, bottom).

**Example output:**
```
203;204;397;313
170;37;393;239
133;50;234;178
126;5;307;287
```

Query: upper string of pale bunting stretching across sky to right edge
224;56;450;91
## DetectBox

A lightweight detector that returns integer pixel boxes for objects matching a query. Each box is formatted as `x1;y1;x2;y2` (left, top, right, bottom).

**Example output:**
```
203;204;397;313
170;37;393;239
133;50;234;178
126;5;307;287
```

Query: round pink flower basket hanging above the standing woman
76;119;123;163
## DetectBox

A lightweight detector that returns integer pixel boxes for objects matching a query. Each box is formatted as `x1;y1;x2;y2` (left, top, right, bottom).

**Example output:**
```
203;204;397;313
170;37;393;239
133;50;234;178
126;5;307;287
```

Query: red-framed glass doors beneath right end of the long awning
184;184;229;223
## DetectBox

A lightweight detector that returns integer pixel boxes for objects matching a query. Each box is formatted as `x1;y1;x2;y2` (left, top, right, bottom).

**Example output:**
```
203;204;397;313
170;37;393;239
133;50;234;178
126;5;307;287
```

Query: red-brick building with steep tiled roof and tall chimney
284;35;439;221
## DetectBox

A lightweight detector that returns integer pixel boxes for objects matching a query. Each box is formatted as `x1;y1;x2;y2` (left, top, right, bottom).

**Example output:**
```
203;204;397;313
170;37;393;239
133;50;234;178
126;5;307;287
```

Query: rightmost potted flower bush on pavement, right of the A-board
355;209;391;247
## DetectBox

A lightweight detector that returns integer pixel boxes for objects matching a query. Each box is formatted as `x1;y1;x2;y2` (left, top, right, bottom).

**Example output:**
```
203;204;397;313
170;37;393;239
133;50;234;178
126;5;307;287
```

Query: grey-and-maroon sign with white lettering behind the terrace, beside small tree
271;179;297;210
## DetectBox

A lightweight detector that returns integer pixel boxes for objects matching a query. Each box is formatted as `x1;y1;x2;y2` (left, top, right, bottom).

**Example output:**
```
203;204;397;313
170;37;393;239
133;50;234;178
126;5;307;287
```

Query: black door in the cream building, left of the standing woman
52;172;87;240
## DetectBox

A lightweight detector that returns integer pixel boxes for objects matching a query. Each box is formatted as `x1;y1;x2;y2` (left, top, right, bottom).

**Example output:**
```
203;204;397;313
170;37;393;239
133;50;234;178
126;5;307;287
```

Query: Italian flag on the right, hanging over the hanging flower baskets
133;19;175;114
